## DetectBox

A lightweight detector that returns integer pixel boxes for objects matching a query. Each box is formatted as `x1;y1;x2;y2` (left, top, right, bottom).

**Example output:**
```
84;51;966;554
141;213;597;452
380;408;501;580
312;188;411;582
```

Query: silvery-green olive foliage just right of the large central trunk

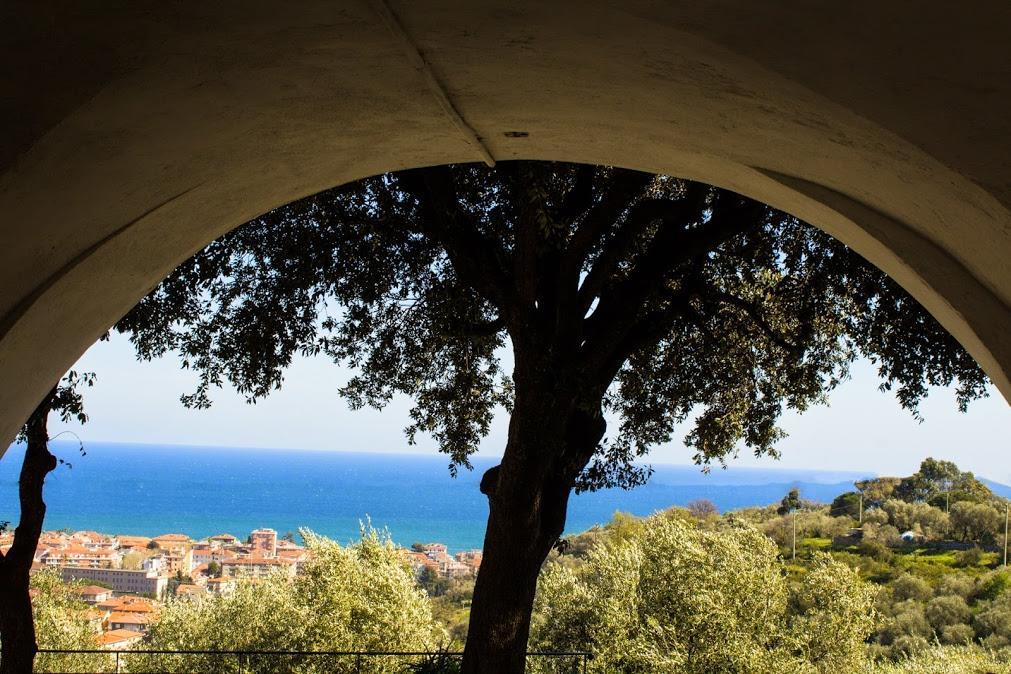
531;514;874;674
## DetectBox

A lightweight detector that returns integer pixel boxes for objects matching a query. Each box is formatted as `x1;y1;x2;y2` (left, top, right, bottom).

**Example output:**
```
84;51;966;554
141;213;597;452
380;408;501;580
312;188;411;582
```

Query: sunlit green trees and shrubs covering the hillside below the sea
23;459;1011;674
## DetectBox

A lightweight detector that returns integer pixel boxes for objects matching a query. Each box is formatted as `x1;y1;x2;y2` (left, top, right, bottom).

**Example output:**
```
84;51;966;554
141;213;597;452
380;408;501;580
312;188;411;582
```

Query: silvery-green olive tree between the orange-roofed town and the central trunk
140;527;446;674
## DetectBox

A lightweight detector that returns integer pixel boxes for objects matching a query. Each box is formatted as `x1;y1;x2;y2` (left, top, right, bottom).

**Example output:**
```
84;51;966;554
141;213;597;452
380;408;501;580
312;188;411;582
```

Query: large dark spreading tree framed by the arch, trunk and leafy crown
117;162;986;673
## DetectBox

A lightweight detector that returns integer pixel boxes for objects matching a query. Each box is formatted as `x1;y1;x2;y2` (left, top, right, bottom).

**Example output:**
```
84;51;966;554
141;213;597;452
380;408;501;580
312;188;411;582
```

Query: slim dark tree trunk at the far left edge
0;394;57;674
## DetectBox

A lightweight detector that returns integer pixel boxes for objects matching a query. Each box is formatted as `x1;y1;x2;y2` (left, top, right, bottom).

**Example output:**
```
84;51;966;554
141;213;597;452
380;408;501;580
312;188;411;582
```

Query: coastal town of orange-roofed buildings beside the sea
0;528;481;650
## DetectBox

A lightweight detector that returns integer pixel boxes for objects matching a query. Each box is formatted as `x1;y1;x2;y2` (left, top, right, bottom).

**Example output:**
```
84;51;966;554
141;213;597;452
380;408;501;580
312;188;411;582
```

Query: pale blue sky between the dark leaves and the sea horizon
45;335;1011;483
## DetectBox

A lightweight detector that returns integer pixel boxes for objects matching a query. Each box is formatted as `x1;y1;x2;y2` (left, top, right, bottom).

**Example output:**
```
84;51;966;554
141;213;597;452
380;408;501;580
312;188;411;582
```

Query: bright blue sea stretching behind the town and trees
0;443;869;551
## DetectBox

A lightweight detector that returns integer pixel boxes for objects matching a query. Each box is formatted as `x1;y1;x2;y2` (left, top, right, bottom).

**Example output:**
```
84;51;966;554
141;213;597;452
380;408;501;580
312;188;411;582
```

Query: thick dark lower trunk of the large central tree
463;387;605;674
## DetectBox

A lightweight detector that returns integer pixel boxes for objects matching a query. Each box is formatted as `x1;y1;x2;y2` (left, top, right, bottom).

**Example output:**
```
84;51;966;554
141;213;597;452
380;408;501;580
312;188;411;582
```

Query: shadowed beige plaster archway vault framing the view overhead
0;2;1011;452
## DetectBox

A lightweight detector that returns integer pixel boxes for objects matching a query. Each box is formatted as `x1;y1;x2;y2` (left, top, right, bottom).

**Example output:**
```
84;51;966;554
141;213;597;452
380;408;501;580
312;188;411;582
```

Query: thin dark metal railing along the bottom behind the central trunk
36;649;592;674
